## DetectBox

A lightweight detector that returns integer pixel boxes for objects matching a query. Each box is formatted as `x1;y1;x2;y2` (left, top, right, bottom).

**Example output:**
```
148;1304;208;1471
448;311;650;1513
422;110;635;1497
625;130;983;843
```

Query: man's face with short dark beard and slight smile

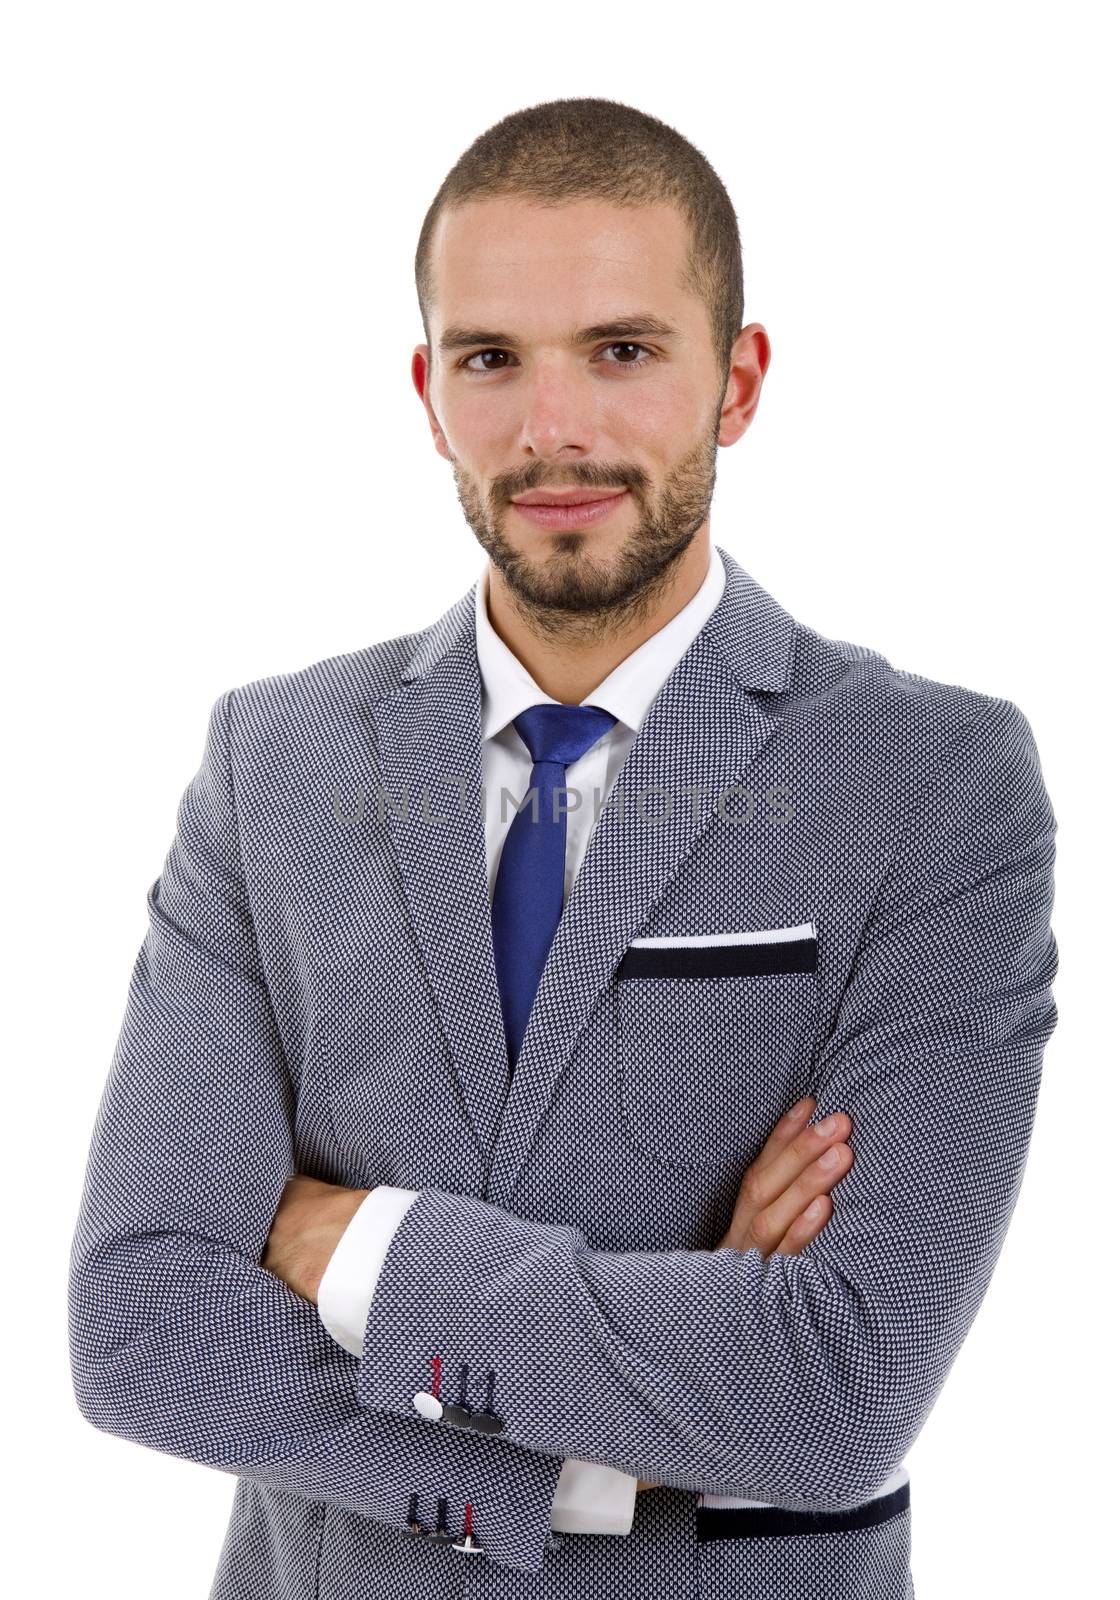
413;198;748;622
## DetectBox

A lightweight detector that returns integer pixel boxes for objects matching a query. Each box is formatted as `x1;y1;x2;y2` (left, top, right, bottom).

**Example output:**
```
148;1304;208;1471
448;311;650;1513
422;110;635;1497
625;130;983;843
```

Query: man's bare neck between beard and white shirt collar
486;526;712;706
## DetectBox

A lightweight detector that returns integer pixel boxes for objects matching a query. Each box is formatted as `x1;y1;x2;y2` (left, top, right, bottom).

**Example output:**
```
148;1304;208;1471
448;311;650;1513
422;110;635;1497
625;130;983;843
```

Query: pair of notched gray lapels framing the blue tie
358;546;797;1205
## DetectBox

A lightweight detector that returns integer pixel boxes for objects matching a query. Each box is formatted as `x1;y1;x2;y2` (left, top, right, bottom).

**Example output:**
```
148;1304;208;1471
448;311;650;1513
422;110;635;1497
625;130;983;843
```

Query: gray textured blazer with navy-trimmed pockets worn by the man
69;547;1058;1600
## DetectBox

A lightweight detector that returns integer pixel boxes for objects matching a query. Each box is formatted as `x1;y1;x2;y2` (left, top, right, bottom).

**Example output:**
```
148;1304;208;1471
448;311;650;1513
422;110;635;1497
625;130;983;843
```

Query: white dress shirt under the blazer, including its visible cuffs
318;547;729;1533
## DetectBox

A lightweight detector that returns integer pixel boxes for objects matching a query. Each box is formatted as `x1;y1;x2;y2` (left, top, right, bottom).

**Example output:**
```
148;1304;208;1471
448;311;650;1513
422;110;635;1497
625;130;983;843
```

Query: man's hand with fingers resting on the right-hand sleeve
638;1098;854;1490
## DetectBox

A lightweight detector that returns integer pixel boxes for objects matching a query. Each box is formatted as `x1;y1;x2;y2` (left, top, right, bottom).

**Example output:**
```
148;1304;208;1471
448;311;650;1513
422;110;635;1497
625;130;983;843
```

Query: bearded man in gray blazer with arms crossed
70;99;1058;1600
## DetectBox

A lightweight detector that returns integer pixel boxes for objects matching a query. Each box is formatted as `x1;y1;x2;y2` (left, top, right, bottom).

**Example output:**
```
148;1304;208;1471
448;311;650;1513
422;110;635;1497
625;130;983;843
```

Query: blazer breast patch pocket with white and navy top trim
613;923;818;1163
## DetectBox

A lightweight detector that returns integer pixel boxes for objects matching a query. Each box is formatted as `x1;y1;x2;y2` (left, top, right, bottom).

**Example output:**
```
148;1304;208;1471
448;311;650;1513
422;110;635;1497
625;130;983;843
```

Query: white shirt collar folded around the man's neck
475;546;726;739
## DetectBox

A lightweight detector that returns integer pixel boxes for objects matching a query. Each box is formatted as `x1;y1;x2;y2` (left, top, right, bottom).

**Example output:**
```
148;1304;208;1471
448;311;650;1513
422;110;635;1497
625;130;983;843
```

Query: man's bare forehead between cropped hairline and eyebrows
432;197;704;328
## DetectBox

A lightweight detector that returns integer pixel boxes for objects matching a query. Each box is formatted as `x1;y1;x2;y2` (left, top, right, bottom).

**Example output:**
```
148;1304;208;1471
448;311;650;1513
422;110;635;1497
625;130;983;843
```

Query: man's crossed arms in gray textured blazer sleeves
70;691;1056;1570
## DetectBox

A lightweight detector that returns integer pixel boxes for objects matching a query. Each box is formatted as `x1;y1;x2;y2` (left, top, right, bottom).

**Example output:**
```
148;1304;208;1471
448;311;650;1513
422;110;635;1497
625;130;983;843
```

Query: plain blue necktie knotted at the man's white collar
491;706;618;1069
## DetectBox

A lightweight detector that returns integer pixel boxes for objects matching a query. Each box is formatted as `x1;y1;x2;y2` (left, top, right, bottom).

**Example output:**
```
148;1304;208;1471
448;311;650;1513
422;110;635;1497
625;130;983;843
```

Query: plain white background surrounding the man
0;0;1120;1600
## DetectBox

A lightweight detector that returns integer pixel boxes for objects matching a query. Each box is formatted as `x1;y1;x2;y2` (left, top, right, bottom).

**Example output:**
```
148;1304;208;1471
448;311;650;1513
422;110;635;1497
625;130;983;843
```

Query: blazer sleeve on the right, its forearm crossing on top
358;696;1058;1510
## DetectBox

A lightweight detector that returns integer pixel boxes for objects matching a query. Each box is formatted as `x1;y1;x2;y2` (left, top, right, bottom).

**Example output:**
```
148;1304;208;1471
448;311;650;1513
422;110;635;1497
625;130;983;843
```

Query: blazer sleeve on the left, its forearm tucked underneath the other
69;690;562;1571
